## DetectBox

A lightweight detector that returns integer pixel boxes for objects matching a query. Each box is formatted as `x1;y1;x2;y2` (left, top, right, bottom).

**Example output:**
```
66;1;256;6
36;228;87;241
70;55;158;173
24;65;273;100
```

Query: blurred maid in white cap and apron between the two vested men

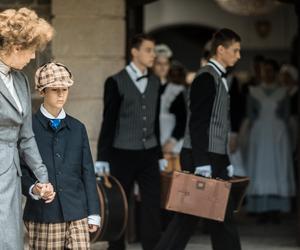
153;44;186;155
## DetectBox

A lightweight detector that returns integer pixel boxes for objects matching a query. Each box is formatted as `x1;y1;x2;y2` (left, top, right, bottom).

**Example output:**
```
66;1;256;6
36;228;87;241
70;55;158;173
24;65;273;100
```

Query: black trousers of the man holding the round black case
108;148;161;250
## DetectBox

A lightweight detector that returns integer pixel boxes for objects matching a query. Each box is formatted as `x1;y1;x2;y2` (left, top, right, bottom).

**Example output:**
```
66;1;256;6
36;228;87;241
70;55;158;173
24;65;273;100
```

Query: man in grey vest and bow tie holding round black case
95;34;166;250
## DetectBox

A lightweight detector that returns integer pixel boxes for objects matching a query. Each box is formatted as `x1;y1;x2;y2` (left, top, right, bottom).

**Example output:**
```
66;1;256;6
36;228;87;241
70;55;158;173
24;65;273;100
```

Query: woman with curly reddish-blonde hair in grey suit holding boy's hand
0;8;55;250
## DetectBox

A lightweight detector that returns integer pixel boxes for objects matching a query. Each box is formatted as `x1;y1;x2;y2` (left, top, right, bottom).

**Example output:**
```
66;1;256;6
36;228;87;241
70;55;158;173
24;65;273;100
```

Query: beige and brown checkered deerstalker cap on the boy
35;62;74;91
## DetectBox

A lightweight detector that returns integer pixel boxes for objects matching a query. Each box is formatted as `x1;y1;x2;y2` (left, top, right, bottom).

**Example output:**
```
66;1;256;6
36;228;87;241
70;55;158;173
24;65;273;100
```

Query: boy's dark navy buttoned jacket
22;111;99;223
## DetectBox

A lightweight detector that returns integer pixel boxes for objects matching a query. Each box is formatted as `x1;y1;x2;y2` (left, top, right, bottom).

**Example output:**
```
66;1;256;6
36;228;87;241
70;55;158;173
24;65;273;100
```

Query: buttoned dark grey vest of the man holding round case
113;69;160;150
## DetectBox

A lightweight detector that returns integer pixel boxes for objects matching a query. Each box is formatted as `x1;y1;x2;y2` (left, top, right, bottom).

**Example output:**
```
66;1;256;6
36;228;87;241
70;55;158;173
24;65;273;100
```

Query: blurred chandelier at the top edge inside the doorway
215;0;279;16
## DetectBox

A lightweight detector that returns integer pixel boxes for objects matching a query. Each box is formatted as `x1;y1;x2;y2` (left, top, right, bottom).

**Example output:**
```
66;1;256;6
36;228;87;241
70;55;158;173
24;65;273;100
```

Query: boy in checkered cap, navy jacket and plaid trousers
22;62;100;250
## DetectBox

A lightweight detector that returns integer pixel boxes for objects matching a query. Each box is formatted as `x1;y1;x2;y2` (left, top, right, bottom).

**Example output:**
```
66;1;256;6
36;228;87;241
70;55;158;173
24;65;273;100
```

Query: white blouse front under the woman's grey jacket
0;61;23;113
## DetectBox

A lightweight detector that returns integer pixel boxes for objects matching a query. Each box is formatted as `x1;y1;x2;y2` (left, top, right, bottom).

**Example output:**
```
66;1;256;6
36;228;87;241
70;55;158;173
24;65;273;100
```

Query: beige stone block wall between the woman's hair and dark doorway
52;0;126;159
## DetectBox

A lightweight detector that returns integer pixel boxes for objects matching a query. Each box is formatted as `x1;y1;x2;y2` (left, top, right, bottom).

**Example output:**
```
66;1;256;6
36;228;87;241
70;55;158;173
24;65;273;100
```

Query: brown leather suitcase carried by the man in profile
165;171;231;221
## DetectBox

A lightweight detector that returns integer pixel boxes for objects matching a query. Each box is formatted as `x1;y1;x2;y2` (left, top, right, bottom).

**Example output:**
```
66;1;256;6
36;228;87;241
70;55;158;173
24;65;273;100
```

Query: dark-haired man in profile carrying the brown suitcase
155;29;241;250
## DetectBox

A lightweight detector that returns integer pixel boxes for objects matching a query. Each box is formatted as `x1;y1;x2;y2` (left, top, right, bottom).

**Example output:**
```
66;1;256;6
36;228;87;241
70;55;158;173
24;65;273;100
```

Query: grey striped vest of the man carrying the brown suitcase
183;65;231;154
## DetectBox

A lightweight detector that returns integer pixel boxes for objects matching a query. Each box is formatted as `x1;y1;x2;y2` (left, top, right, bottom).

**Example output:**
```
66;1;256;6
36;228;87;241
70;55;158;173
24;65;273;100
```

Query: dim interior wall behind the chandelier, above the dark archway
145;0;297;50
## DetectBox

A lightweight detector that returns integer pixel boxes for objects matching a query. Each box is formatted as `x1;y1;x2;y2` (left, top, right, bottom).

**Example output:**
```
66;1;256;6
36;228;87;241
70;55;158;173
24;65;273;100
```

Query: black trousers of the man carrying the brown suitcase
155;148;241;250
